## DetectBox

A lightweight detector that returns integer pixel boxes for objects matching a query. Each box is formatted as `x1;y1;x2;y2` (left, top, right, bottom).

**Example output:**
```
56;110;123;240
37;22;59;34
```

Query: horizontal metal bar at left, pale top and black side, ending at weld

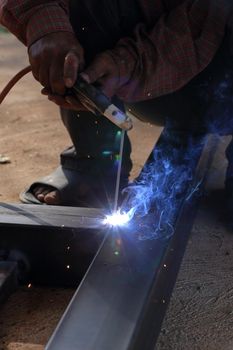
0;203;106;287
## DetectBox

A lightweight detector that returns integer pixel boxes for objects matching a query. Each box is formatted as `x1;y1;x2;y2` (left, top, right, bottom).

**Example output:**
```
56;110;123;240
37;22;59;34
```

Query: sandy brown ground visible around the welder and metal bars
0;34;233;350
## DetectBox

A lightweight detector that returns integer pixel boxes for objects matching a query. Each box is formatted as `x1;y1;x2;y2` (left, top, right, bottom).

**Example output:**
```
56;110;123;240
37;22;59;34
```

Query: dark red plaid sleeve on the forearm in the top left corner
0;0;73;46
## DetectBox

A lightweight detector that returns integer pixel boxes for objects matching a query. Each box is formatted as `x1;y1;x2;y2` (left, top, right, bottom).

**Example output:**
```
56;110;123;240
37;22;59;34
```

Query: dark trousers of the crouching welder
61;0;233;180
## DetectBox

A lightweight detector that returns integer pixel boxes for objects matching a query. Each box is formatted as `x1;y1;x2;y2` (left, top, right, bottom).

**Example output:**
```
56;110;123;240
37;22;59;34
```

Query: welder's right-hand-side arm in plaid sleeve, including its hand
86;0;232;102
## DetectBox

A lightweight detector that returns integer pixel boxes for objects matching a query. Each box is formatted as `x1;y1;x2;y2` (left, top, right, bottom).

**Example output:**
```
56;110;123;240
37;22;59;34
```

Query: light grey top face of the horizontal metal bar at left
0;203;105;229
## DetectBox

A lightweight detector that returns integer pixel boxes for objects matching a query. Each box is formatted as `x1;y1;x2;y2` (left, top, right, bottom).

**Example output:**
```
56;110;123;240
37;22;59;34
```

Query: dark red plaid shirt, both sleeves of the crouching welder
0;0;232;102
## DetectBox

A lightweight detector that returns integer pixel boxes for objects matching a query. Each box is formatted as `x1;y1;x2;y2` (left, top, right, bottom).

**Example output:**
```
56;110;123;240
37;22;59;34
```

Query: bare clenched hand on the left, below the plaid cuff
28;32;84;95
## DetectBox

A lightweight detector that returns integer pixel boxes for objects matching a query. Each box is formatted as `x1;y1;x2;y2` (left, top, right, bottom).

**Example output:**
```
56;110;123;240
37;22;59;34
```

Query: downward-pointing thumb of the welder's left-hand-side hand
64;51;80;88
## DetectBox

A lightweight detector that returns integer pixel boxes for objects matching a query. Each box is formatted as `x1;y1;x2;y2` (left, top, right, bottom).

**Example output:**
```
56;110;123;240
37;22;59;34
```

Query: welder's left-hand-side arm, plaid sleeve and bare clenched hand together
0;0;84;95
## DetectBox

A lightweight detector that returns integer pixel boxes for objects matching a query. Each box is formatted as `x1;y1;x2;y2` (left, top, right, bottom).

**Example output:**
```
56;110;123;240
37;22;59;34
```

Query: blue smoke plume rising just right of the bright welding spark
123;130;203;240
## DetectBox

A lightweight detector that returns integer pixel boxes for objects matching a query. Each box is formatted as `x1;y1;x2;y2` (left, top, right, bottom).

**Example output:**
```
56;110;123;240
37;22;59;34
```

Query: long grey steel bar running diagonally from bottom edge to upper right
46;138;216;350
